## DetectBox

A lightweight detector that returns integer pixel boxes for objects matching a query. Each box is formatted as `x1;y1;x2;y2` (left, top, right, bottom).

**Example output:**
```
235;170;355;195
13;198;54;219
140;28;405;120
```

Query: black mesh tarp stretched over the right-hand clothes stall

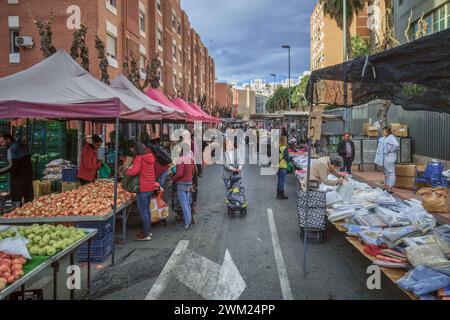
307;29;450;113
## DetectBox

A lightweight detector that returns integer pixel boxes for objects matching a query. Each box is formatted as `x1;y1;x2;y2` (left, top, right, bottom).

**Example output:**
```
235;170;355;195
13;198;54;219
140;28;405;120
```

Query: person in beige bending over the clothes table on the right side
302;155;345;191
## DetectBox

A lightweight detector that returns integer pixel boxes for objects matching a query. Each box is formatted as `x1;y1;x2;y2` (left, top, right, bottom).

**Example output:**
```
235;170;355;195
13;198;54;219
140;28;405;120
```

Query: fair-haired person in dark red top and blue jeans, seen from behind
172;149;196;229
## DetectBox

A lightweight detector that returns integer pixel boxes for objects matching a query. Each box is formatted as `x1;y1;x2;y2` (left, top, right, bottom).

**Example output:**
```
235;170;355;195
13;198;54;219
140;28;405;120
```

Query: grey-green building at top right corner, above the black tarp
394;0;450;43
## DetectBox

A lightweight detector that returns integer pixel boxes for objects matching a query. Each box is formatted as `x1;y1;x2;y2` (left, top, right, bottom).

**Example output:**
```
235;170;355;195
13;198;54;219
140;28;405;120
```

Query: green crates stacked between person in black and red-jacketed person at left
29;121;67;180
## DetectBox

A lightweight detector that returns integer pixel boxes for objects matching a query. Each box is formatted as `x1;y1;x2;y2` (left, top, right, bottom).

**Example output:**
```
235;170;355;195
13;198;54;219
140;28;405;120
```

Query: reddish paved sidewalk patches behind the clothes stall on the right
352;168;450;224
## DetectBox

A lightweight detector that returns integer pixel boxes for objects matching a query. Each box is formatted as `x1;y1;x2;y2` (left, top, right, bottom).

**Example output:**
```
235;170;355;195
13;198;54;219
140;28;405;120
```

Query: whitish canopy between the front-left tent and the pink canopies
110;75;185;120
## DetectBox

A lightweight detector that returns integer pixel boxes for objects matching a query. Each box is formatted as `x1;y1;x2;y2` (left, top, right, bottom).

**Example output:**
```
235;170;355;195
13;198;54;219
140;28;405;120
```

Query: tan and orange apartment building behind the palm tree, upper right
311;1;376;70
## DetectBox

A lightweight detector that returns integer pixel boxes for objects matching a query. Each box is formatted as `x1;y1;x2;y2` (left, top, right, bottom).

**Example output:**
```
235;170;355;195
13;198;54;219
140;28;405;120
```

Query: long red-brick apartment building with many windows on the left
0;0;215;105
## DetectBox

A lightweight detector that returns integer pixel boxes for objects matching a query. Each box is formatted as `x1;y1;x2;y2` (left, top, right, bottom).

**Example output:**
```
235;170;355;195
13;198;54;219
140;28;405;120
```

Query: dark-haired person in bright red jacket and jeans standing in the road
126;142;159;241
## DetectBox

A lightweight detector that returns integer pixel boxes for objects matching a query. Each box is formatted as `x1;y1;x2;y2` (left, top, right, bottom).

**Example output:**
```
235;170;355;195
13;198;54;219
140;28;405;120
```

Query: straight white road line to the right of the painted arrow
267;208;294;300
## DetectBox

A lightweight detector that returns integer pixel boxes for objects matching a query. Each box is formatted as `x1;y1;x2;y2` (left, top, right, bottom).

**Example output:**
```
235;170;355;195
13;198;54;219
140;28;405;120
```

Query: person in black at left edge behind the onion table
0;134;34;203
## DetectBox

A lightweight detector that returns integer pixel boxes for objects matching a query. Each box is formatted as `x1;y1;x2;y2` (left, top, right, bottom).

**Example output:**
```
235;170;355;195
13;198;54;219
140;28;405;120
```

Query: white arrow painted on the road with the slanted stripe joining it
146;240;246;300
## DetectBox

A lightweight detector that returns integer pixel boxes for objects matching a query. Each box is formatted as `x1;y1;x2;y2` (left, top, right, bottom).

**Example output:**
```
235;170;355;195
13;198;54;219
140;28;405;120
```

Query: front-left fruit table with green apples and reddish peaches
0;225;97;300
